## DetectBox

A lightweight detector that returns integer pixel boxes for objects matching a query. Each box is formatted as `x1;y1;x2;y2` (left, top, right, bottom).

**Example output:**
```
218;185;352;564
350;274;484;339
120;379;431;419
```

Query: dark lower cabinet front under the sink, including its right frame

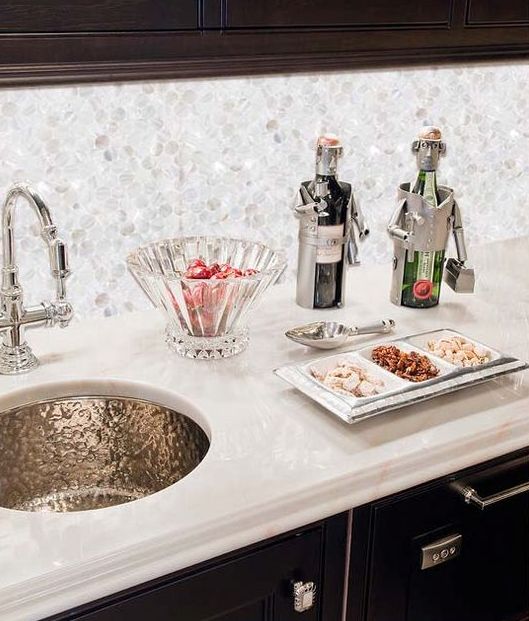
48;514;347;621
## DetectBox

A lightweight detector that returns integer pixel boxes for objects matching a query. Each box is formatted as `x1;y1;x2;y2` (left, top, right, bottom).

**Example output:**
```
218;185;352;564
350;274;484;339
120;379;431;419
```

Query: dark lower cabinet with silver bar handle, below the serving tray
348;453;529;621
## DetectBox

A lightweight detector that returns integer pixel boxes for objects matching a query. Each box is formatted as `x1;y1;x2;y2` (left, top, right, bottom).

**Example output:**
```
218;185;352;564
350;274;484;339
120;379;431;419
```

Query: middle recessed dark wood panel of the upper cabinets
225;0;451;29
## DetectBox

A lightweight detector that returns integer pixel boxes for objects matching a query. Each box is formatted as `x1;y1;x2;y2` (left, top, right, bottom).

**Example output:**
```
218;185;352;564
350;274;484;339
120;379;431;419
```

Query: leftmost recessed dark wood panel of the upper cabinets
0;0;198;33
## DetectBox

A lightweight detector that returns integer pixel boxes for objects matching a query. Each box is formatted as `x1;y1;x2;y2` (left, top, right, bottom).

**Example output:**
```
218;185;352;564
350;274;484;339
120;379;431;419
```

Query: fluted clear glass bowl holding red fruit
127;237;286;359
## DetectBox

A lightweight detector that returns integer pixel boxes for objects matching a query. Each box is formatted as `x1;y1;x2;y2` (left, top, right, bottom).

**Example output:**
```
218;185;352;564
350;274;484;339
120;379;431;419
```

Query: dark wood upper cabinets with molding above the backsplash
0;0;529;84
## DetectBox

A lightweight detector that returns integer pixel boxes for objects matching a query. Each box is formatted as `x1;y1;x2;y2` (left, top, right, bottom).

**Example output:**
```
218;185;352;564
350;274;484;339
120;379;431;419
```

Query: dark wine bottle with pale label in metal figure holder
308;135;350;308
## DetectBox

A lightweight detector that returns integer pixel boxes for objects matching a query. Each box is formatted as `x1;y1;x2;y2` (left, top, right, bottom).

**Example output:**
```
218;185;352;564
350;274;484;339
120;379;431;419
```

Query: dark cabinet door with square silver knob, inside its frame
68;530;322;621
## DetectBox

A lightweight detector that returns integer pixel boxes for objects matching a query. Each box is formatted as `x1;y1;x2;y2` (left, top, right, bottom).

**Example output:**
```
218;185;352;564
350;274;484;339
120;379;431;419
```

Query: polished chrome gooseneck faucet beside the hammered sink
0;184;73;375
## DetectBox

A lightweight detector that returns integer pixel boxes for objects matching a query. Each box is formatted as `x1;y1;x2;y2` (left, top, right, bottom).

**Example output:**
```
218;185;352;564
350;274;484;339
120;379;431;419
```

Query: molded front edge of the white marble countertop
0;394;529;620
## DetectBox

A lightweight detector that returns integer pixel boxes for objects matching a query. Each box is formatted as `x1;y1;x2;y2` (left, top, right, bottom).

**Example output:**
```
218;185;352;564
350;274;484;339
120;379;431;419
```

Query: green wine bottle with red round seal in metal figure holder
401;127;445;308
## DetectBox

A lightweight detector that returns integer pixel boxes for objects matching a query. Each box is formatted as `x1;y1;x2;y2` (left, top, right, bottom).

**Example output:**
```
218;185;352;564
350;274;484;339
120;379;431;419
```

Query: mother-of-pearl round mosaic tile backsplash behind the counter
0;62;529;317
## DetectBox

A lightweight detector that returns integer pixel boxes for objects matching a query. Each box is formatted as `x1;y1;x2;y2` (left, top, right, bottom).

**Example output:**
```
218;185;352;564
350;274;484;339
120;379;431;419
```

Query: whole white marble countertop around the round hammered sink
0;238;529;621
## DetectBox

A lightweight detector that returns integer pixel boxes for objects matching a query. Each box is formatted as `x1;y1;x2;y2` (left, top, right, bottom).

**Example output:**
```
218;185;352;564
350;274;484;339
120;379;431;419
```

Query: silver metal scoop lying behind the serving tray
285;319;395;349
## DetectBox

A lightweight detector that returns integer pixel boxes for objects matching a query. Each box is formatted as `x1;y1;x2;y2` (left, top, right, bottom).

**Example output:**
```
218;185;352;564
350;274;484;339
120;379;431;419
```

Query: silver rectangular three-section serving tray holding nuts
274;328;529;423
